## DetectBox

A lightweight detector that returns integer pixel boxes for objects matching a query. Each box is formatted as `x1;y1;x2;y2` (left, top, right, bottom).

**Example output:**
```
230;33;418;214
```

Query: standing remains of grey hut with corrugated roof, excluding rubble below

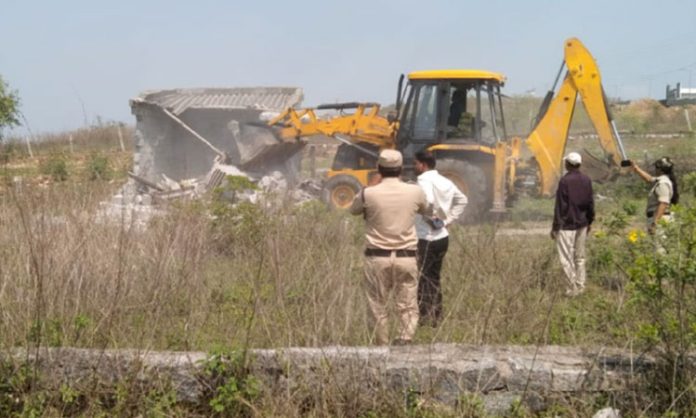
130;87;302;183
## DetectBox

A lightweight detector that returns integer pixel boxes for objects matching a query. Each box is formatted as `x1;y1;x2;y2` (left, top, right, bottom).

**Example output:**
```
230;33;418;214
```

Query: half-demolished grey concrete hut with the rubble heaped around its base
97;87;320;228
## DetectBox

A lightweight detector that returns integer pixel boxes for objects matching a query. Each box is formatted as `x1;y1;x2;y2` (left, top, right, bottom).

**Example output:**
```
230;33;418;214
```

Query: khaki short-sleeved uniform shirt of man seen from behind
350;177;431;250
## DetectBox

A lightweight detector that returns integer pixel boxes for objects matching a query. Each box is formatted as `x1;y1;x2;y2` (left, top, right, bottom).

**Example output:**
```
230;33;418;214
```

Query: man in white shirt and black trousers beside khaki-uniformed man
415;151;468;326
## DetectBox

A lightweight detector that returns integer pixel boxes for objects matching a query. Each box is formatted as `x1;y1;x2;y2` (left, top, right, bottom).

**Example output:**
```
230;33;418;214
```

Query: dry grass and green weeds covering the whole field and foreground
0;115;696;417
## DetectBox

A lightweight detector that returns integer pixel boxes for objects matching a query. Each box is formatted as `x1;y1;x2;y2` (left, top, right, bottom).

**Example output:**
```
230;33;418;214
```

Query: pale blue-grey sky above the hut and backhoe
0;0;696;135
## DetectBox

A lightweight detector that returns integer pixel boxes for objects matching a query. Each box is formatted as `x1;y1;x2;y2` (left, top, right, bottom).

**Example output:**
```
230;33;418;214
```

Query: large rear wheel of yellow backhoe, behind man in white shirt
436;158;491;223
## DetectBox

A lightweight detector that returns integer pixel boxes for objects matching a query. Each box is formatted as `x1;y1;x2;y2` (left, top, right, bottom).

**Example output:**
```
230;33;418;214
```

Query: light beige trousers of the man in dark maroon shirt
556;227;587;292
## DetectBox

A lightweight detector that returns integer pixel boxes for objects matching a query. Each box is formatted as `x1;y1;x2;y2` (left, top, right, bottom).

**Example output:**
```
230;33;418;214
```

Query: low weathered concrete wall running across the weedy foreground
5;344;653;411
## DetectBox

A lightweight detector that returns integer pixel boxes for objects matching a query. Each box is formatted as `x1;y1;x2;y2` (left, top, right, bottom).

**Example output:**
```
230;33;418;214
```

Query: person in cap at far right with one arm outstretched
631;157;679;238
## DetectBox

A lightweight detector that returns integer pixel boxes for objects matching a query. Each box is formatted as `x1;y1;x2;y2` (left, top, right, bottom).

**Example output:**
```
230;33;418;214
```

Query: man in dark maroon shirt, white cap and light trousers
551;152;594;296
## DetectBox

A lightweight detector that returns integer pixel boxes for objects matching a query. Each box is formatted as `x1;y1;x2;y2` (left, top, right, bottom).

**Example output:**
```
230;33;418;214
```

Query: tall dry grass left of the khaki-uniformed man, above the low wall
0;183;366;349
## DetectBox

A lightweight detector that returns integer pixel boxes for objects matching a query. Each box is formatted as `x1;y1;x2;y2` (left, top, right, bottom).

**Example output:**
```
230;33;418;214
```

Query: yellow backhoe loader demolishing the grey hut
245;38;626;220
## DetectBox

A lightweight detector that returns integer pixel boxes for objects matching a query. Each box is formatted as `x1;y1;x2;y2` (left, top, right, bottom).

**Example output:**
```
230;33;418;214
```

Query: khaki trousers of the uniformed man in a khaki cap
365;252;418;345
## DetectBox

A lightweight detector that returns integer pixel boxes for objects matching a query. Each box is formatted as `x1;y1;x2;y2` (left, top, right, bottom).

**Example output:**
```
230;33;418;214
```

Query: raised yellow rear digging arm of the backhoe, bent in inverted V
526;38;626;195
